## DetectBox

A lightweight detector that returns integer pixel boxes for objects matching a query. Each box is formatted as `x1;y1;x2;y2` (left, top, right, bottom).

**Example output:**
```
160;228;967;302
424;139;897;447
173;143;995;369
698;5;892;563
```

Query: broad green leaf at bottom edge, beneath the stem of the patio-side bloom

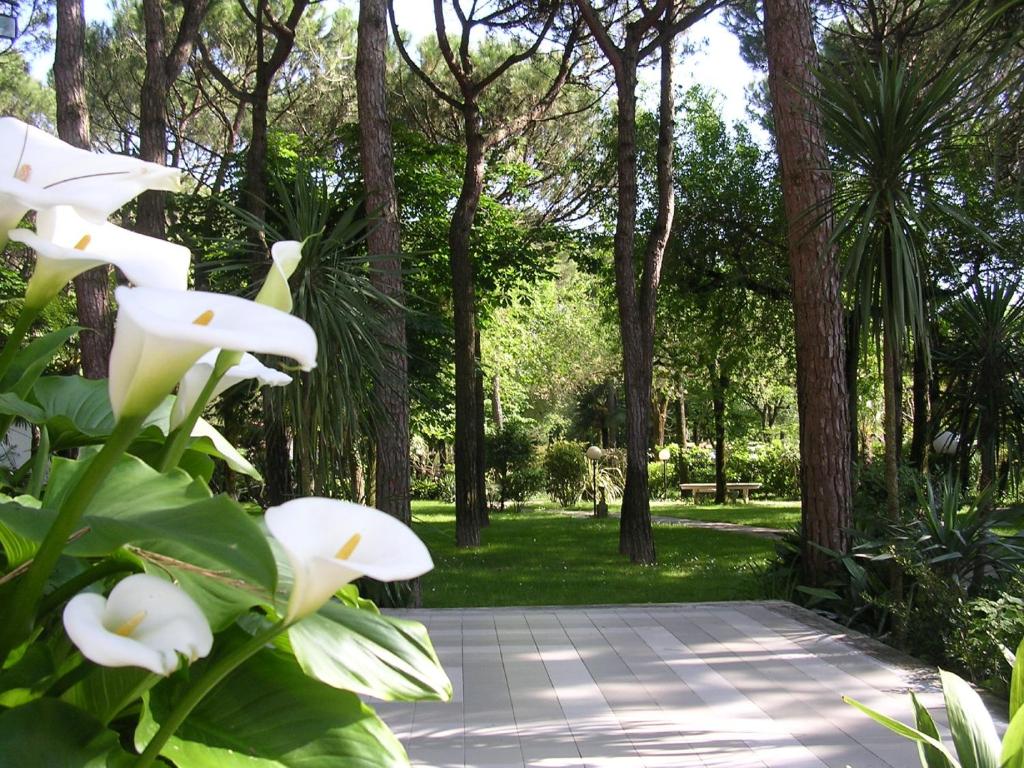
135;650;409;768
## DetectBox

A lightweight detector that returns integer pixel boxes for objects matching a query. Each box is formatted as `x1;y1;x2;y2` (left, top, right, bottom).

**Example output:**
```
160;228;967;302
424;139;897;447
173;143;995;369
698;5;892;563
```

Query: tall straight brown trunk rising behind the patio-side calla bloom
355;0;411;540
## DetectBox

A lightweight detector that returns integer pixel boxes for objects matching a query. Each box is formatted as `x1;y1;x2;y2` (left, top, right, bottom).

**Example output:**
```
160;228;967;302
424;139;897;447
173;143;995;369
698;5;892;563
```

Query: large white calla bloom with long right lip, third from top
110;288;316;419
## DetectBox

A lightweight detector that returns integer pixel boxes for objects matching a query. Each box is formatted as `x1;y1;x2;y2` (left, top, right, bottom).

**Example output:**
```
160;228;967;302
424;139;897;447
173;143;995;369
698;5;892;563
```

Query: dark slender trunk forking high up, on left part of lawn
449;103;484;547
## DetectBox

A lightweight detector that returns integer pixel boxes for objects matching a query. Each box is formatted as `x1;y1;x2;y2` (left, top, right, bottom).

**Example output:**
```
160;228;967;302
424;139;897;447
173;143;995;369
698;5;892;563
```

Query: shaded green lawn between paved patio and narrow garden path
413;502;774;608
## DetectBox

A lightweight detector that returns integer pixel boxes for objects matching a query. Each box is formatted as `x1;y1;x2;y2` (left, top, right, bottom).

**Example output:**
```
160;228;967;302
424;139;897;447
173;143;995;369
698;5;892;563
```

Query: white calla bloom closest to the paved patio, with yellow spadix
264;498;434;623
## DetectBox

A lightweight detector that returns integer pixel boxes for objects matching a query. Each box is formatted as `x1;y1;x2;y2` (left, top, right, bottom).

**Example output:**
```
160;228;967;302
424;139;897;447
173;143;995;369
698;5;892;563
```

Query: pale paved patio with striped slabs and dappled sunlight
376;602;999;768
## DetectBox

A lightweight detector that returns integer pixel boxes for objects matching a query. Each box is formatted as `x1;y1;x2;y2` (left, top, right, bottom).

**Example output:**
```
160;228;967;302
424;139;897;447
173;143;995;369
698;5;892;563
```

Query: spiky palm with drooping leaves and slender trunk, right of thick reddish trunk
818;51;987;519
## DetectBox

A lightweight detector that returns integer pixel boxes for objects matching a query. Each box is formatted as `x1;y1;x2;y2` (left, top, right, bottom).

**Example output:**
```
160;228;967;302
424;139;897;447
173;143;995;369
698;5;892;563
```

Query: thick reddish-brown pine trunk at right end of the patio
764;0;850;585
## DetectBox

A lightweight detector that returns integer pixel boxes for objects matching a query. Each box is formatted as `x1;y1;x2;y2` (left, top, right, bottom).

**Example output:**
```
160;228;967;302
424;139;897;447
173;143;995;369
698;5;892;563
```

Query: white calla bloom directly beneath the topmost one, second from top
10;206;191;307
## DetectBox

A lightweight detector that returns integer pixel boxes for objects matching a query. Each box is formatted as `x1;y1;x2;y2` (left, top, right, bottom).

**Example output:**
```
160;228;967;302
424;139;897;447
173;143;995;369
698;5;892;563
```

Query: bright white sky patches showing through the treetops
68;0;759;135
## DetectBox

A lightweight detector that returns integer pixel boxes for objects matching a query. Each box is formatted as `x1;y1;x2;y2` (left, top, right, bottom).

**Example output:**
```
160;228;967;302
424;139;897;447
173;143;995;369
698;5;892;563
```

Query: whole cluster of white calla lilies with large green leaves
0;118;451;768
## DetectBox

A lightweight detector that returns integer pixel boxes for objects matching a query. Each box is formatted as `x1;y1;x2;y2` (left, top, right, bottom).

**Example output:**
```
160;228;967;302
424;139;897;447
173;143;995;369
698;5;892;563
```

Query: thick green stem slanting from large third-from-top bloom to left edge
0;416;145;666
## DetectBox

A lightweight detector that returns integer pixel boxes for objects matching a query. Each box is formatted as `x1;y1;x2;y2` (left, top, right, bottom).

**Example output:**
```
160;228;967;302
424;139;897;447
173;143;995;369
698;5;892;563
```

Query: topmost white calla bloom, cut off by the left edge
0;118;181;244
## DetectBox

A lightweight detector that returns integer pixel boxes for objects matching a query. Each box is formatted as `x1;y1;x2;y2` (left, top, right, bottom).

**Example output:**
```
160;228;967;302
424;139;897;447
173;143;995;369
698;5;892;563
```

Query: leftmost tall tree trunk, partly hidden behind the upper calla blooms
53;0;114;379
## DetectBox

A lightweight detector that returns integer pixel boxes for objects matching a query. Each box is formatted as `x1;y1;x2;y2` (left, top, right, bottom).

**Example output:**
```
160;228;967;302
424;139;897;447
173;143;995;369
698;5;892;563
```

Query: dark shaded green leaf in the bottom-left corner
0;698;125;768
